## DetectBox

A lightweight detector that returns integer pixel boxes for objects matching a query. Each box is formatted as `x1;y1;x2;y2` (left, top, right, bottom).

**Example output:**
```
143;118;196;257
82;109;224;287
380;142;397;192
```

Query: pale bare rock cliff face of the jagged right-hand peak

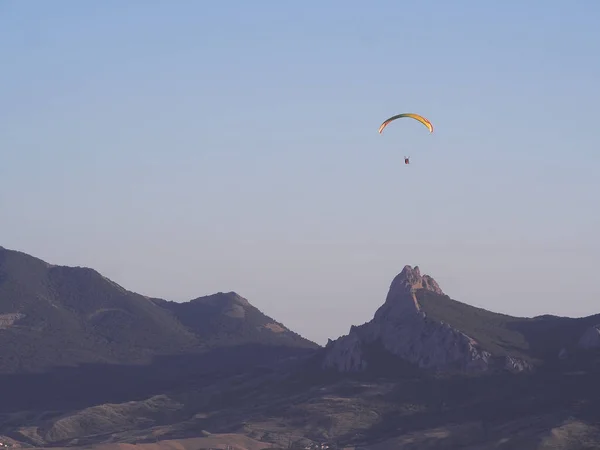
322;266;529;372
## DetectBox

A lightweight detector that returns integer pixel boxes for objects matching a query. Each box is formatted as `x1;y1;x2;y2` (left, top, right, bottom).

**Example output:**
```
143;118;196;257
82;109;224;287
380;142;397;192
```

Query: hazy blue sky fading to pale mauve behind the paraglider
0;0;600;344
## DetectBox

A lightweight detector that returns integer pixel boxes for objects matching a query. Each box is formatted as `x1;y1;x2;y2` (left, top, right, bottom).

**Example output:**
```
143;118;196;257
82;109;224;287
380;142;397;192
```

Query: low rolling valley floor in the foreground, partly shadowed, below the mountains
0;373;600;450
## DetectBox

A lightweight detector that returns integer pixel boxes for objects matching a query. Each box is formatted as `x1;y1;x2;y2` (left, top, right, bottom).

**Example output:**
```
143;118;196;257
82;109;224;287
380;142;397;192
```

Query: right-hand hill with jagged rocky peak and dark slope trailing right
322;266;600;373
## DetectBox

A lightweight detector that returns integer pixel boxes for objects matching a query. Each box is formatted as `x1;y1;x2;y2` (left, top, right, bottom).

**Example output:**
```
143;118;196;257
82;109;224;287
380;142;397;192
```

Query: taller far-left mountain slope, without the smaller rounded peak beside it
0;249;200;373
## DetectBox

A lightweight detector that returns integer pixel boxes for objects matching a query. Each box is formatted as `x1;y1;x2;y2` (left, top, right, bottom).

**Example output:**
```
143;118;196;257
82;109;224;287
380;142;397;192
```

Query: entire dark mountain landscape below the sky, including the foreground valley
0;247;600;450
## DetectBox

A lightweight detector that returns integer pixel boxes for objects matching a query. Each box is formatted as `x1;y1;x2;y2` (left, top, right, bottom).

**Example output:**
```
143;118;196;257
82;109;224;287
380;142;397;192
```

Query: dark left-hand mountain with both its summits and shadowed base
0;247;319;410
